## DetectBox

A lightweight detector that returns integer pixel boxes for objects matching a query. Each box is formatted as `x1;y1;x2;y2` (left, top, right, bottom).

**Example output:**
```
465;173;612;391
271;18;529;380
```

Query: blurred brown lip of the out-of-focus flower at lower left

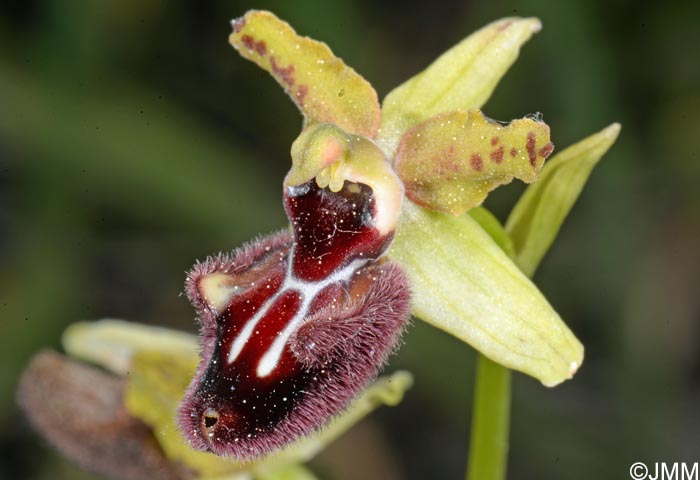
17;350;192;480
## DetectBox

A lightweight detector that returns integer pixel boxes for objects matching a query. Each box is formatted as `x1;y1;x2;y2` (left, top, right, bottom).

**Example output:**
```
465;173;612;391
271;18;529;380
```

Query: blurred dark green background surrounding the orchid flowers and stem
0;0;700;479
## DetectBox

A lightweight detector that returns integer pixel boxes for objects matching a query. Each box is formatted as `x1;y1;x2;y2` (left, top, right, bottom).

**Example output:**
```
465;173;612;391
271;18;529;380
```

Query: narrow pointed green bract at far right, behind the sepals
506;123;620;276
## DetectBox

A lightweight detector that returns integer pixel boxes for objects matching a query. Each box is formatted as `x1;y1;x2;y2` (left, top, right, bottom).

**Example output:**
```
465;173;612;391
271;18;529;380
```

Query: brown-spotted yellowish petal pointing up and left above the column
229;10;380;138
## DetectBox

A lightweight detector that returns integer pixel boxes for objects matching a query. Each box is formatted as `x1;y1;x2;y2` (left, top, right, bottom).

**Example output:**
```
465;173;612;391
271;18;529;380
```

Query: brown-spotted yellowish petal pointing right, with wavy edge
394;110;554;215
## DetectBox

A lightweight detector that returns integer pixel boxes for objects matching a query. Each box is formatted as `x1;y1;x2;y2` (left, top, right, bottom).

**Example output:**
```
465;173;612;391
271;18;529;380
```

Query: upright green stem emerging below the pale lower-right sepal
467;354;511;480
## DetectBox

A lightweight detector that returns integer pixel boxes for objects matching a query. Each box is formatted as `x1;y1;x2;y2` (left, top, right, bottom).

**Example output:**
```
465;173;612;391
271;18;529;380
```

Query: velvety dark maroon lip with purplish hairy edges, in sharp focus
180;180;410;459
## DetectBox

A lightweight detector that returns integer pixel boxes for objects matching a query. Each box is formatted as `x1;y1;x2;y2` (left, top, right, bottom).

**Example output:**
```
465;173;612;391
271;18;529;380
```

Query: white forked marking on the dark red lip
228;250;369;378
